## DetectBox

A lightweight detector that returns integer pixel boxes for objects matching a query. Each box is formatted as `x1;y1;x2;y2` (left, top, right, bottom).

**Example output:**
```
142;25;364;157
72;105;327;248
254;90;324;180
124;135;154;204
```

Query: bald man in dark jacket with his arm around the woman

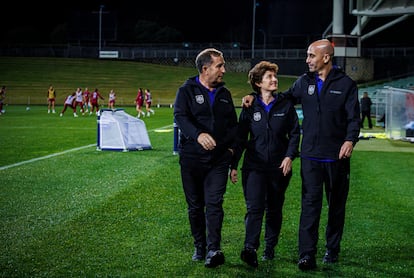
243;39;360;271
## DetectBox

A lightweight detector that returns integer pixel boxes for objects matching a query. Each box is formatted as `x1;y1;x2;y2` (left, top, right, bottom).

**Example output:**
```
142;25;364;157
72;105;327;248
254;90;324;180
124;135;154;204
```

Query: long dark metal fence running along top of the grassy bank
0;43;414;63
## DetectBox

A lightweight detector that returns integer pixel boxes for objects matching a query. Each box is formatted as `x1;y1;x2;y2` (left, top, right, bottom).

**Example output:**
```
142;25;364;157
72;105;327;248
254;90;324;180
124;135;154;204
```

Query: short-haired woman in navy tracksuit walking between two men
230;61;300;267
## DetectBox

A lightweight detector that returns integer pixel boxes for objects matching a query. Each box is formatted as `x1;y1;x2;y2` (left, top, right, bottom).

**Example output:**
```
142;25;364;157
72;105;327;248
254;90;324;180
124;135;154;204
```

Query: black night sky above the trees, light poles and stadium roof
0;0;414;46
